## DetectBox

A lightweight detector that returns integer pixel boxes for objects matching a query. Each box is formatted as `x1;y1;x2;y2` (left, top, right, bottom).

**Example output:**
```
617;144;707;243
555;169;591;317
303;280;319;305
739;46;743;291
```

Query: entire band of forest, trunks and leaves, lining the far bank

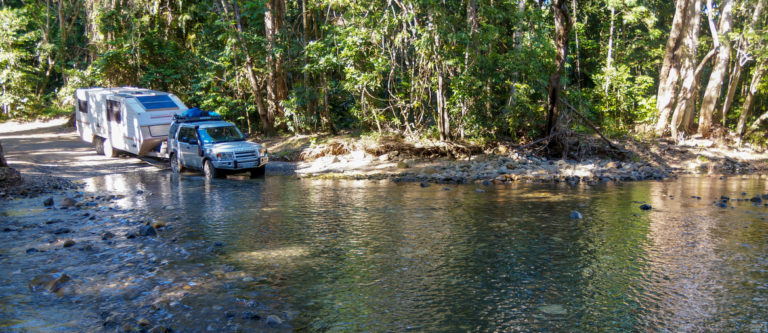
0;0;768;145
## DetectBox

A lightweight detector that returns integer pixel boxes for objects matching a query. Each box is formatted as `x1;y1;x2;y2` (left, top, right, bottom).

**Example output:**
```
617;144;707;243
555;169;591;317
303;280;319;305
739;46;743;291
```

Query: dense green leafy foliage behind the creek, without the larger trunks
0;0;768;142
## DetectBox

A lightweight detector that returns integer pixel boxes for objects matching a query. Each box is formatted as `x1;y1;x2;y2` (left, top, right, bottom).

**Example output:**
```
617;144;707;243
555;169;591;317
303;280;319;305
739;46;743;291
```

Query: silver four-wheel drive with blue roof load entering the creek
168;116;269;179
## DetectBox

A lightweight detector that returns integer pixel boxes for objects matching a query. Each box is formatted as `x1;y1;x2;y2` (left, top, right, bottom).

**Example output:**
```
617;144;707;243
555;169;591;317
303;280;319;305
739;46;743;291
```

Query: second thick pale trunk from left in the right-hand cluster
669;0;701;140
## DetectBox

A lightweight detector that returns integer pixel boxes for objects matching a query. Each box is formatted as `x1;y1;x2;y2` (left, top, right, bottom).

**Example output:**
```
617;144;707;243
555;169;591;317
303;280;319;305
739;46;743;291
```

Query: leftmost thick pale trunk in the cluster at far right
655;0;698;135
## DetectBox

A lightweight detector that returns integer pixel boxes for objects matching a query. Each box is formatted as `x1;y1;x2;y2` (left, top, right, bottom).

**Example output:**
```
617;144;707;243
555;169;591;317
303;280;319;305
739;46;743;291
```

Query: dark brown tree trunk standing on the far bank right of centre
544;0;571;136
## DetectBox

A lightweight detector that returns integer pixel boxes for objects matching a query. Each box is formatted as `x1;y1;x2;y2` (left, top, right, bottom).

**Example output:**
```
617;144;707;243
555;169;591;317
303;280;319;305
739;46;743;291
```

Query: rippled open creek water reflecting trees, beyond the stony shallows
79;173;768;332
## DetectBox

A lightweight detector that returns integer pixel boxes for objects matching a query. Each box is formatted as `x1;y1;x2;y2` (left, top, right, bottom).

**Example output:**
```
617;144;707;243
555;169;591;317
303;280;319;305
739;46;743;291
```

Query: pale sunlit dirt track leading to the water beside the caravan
0;119;166;180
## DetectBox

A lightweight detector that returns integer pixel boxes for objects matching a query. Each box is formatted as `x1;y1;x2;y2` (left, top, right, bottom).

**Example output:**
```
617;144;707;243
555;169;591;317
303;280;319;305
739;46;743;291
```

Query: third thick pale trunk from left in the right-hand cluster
699;0;733;135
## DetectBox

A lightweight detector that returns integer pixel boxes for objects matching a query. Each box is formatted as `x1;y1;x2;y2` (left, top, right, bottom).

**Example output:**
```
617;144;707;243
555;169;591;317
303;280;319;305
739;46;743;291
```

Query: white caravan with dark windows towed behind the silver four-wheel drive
75;87;187;157
